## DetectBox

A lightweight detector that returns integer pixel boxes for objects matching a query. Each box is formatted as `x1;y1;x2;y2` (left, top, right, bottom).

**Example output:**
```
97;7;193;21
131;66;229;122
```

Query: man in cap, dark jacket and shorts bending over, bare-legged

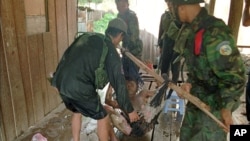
52;18;139;141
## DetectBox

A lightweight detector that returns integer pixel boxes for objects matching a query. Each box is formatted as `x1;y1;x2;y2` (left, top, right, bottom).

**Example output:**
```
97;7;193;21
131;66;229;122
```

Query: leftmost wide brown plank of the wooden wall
1;0;28;140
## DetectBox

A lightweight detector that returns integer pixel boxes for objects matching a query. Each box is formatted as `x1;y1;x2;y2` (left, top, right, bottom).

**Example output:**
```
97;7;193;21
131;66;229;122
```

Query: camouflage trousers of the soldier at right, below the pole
180;103;227;141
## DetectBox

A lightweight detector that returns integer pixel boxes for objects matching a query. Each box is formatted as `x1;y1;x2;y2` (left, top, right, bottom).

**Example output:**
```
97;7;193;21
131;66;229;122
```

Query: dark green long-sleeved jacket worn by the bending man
52;33;134;113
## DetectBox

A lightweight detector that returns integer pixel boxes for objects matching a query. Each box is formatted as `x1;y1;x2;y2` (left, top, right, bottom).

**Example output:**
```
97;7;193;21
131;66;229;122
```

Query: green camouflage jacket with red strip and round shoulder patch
183;8;246;111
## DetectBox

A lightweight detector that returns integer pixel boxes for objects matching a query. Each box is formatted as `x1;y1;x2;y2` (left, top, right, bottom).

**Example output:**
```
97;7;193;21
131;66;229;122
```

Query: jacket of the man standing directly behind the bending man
117;9;143;58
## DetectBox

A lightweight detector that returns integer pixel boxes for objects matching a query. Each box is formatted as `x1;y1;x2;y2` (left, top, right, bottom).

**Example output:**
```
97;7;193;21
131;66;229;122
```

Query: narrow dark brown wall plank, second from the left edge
12;0;35;127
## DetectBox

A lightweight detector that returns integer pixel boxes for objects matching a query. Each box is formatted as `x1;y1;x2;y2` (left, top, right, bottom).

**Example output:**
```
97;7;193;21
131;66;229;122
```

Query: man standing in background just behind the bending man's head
115;0;143;89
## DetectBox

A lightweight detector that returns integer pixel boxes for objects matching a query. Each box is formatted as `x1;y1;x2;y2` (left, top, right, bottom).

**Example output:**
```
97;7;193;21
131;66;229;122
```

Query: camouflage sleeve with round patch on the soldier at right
203;27;246;111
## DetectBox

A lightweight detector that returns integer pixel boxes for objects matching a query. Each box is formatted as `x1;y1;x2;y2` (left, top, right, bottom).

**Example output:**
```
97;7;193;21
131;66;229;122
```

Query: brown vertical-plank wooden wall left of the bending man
0;0;77;141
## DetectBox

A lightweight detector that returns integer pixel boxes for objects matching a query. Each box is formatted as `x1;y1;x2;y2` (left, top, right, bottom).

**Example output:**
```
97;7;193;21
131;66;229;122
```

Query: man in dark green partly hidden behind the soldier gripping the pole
158;0;181;83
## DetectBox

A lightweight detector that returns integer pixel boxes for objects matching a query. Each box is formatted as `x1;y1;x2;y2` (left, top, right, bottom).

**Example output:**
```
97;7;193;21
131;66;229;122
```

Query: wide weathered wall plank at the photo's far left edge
1;0;28;140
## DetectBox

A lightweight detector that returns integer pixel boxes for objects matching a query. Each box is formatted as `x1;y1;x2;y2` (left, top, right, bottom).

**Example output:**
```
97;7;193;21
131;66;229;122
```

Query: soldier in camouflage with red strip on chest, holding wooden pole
171;0;245;141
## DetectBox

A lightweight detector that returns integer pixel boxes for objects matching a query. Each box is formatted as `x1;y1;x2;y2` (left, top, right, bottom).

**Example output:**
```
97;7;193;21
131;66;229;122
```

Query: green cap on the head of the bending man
108;18;128;34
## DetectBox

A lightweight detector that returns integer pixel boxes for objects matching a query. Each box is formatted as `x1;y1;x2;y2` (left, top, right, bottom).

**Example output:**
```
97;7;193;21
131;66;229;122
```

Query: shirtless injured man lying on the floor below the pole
104;80;164;137
